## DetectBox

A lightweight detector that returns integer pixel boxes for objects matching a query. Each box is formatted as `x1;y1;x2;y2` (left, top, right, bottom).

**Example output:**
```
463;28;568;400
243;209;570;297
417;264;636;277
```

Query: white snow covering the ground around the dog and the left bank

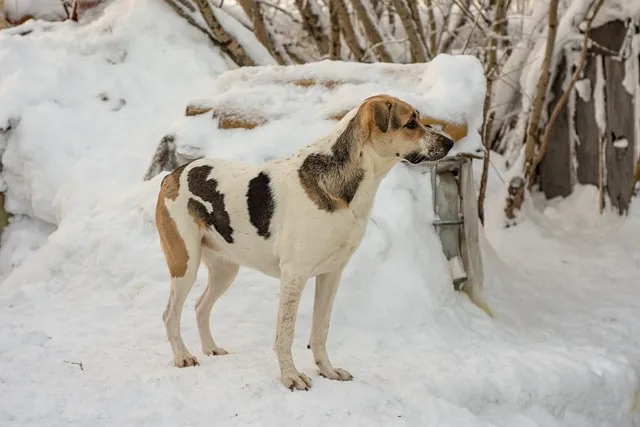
0;0;640;427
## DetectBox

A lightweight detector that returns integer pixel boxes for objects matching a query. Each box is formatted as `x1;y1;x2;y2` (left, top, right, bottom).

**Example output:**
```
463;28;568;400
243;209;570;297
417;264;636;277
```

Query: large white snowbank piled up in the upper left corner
0;0;227;224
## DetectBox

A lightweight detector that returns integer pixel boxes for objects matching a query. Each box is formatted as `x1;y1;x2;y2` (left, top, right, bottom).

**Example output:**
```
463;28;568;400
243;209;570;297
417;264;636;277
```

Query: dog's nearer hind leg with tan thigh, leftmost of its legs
156;200;202;368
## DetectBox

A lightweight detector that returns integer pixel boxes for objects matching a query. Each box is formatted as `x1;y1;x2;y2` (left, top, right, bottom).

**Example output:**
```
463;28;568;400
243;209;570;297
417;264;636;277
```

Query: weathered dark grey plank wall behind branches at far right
538;21;640;214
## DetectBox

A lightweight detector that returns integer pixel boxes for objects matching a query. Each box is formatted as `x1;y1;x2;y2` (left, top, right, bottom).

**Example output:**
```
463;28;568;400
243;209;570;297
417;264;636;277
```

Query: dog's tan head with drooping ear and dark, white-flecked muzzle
359;95;453;164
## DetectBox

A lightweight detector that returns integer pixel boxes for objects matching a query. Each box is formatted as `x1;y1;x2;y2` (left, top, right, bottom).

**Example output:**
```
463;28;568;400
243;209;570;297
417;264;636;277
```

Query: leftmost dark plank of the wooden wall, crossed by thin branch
539;57;573;199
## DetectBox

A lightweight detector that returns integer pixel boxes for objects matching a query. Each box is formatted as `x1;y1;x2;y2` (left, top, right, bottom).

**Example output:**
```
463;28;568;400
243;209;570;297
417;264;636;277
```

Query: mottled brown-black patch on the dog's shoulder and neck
298;119;364;212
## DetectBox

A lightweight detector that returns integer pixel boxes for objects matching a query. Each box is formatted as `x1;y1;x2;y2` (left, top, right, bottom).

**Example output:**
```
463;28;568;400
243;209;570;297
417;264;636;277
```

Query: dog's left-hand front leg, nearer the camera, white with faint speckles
275;274;311;390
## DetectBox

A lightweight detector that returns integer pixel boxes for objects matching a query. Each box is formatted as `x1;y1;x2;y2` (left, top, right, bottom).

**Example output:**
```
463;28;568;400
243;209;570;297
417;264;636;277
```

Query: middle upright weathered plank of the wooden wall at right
574;56;600;185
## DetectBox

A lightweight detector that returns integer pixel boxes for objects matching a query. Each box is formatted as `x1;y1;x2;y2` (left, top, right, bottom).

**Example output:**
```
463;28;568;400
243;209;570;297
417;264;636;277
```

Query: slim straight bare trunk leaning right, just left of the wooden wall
524;0;558;186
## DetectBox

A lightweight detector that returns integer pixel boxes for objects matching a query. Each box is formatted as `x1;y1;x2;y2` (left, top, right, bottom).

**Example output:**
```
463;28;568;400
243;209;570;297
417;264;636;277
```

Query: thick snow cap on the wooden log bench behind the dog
170;55;485;164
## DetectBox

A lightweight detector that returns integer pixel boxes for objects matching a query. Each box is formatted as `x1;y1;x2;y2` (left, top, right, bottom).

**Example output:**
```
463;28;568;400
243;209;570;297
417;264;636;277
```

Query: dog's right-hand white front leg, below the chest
309;267;353;381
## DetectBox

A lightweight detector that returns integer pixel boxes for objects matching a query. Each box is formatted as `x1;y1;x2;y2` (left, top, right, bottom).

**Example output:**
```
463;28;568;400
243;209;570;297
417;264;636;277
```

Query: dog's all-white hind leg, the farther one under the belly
196;246;240;356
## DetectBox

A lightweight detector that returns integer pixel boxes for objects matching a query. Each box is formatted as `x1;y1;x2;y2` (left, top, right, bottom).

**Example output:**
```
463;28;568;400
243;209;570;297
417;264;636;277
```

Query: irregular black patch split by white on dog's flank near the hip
187;166;233;243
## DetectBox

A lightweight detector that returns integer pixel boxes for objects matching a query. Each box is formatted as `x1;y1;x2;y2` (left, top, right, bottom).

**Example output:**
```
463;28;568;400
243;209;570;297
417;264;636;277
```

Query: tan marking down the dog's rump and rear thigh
156;168;189;277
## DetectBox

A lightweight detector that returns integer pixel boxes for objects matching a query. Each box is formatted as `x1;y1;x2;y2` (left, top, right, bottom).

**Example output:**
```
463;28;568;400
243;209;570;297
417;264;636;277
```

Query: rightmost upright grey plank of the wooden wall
604;57;635;214
